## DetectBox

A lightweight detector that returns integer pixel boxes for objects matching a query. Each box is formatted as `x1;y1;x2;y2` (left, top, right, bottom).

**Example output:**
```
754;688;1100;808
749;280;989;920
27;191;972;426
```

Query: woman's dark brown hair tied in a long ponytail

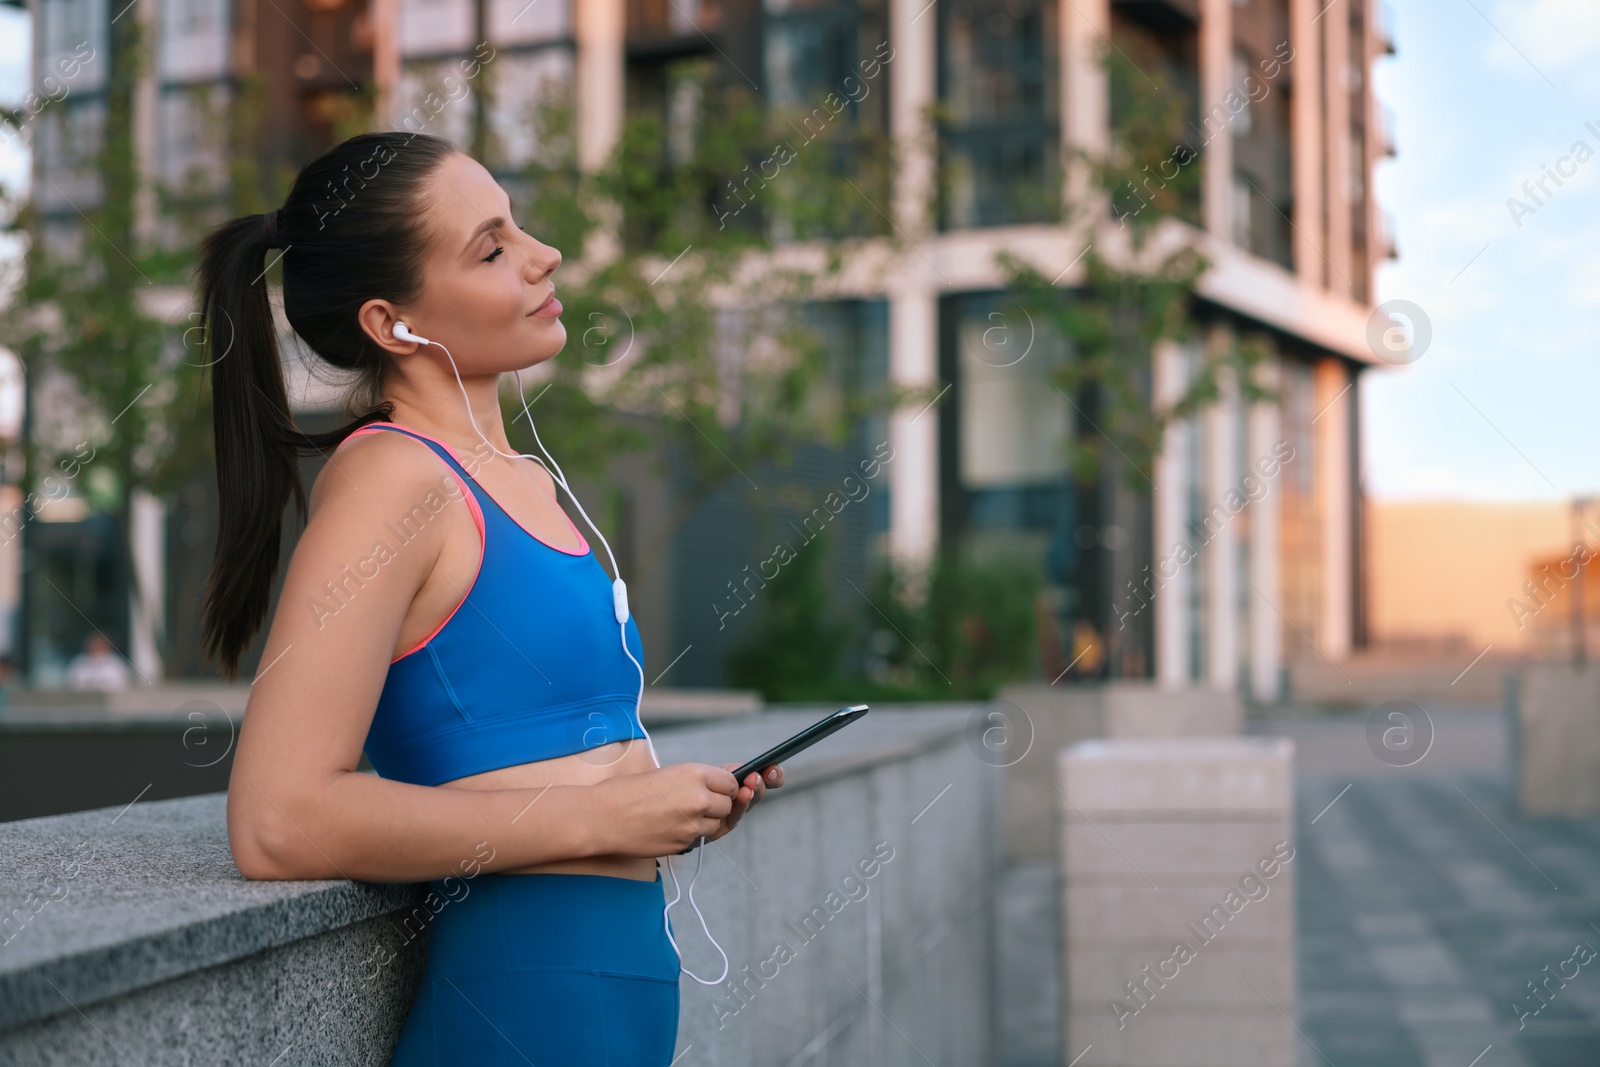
197;131;454;680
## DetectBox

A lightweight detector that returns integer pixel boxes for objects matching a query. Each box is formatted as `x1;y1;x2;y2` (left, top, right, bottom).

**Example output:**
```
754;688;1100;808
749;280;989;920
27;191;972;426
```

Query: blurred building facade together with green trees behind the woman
5;0;1388;701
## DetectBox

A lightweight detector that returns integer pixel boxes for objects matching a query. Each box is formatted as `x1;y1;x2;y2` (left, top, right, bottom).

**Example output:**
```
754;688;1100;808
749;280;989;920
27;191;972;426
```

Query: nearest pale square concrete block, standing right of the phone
1059;737;1296;1067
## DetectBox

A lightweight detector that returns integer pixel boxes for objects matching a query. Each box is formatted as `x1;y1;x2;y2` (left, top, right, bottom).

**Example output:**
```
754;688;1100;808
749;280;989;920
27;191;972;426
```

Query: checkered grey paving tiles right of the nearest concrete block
1296;710;1600;1067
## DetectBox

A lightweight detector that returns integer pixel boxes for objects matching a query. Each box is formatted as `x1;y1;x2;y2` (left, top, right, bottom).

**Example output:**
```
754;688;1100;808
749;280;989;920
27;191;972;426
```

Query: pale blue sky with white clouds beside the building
0;0;1600;501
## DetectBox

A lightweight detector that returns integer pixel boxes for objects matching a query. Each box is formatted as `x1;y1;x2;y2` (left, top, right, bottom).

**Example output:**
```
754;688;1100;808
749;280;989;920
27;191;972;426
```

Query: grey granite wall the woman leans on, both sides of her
0;705;998;1067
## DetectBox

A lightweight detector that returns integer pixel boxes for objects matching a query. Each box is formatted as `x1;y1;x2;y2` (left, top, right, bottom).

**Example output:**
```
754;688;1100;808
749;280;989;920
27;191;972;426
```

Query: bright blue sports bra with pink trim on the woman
341;422;646;785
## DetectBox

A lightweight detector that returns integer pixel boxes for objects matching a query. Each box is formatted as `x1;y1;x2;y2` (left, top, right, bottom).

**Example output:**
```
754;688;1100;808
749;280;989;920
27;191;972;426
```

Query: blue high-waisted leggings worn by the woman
389;870;678;1067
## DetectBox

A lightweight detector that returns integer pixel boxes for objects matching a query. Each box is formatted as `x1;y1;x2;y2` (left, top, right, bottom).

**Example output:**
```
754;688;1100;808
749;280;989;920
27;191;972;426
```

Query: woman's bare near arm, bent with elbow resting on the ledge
227;434;738;881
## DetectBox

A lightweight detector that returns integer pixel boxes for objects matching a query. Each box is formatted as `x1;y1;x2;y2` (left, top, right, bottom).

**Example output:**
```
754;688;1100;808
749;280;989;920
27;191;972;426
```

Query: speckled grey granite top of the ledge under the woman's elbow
0;793;422;1032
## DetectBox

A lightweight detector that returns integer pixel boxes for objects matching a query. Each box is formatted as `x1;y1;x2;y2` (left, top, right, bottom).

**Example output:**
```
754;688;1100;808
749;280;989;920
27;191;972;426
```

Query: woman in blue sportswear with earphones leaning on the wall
198;133;782;1067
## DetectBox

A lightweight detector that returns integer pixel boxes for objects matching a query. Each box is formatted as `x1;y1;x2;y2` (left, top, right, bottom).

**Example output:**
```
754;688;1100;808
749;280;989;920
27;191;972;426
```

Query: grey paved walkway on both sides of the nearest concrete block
997;707;1600;1067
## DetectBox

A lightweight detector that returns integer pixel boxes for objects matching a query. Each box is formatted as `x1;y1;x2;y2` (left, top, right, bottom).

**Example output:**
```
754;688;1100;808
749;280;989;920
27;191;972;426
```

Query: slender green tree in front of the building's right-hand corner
997;28;1274;491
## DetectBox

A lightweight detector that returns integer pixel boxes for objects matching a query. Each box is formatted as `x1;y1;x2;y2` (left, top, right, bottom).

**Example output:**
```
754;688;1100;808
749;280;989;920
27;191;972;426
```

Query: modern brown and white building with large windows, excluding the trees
18;0;1394;699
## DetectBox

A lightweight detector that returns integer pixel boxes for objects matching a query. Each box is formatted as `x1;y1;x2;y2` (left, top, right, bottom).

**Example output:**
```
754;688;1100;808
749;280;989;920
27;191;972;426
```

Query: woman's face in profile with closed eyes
384;152;566;374
